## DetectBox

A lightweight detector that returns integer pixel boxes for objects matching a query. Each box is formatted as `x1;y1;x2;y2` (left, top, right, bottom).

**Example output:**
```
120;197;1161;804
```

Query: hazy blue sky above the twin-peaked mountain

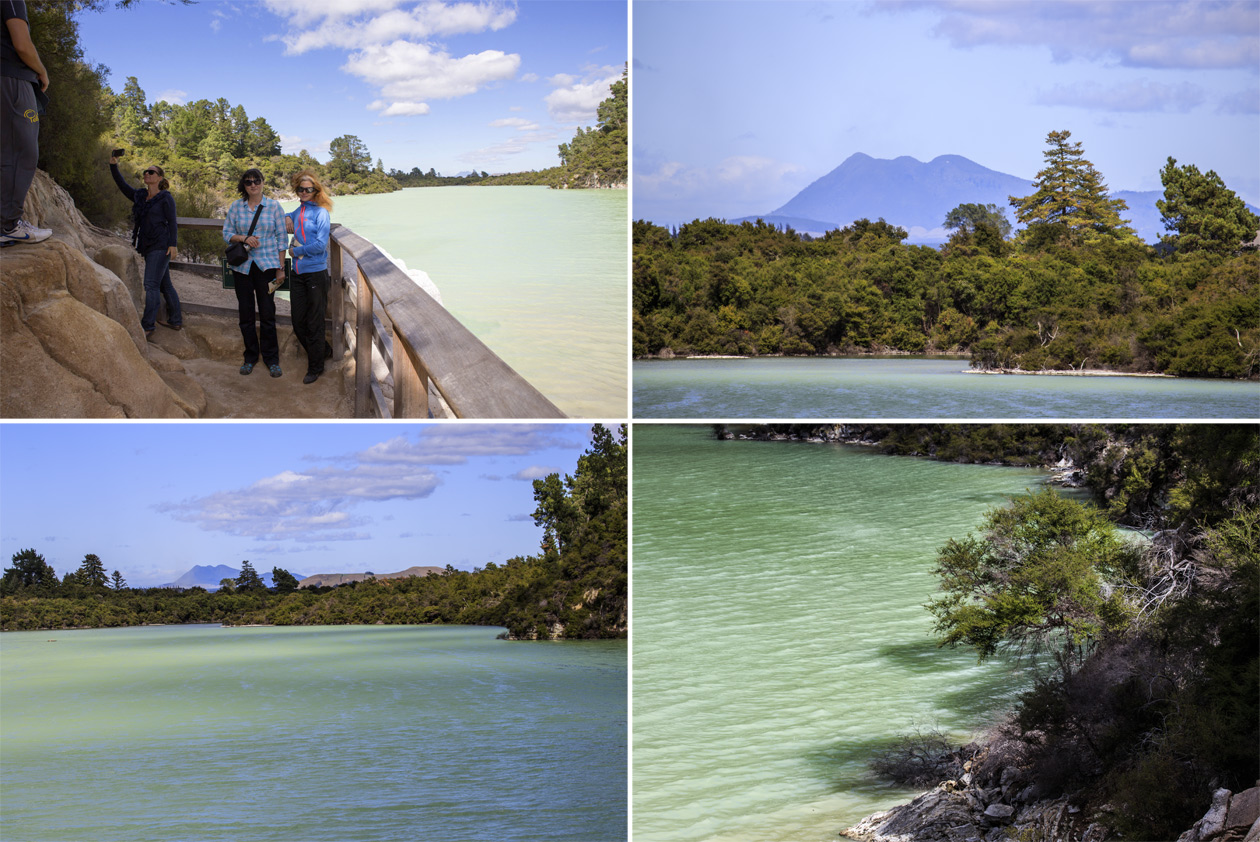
631;0;1260;224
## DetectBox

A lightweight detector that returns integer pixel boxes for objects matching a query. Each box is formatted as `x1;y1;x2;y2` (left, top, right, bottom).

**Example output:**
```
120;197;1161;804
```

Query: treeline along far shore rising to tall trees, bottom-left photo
0;425;629;639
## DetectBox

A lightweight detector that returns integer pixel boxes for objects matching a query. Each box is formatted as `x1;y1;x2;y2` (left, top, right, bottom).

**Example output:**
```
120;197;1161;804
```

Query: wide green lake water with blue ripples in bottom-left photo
0;625;626;842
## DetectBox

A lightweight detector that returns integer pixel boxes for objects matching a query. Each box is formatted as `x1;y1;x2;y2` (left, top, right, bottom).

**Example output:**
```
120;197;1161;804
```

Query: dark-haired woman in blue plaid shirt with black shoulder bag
223;169;289;377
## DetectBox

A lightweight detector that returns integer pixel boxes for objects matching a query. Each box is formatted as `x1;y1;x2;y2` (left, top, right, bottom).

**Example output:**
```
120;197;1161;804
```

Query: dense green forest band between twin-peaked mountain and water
634;132;1260;377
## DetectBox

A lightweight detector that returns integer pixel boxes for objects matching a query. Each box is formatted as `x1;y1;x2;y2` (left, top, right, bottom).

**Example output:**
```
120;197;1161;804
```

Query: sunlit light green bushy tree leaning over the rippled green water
927;489;1138;678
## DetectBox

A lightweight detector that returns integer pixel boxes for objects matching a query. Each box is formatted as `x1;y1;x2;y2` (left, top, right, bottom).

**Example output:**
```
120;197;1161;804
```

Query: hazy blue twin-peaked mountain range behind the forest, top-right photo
728;153;1260;245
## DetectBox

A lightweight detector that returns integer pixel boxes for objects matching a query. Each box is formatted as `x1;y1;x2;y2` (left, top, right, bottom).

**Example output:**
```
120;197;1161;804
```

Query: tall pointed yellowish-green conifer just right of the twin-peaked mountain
1009;131;1133;239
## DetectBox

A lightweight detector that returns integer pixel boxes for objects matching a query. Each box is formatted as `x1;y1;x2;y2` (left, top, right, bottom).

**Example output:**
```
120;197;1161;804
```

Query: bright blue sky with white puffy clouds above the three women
78;0;629;175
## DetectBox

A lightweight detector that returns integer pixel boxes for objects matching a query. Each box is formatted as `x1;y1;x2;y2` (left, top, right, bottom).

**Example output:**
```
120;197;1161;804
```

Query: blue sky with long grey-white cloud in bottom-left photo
0;422;590;586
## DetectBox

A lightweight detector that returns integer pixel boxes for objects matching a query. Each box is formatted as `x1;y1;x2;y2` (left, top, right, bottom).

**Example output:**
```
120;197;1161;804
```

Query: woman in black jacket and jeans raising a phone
110;158;184;338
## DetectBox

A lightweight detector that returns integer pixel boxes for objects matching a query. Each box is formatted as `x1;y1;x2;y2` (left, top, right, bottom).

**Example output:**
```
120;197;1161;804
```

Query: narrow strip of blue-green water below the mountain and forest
634;357;1260;420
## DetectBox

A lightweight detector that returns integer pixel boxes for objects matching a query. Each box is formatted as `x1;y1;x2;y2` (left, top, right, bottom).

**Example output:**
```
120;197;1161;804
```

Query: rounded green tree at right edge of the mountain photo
1155;156;1260;255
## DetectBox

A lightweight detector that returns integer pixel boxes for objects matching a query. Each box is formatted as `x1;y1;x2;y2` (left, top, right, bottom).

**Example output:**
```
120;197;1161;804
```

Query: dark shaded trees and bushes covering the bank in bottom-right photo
735;425;1260;839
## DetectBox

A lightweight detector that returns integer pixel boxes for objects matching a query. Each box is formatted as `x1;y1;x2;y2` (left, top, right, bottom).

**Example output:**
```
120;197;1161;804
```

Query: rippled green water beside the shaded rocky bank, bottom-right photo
631;424;1043;842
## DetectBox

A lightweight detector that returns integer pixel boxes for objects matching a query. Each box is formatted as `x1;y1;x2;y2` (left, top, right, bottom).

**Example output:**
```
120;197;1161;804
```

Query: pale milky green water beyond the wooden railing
322;187;630;418
